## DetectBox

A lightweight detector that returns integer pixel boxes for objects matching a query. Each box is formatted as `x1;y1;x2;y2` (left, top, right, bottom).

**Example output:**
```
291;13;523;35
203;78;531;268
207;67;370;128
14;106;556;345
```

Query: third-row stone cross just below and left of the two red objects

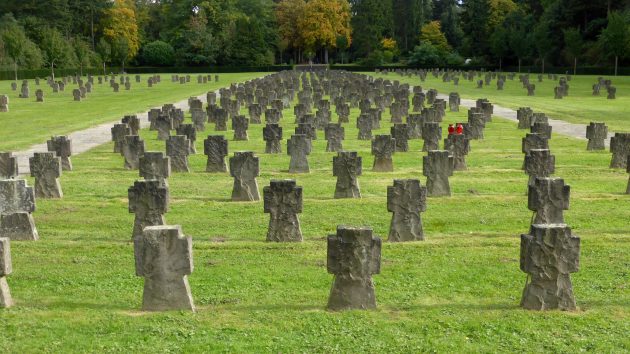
422;150;453;197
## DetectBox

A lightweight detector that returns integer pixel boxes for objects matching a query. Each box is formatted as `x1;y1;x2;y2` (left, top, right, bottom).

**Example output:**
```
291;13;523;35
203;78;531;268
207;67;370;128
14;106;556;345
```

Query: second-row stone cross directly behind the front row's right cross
527;177;571;224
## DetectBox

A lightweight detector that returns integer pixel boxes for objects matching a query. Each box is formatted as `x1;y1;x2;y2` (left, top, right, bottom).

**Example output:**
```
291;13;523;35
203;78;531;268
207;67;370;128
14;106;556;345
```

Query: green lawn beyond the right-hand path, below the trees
375;73;630;132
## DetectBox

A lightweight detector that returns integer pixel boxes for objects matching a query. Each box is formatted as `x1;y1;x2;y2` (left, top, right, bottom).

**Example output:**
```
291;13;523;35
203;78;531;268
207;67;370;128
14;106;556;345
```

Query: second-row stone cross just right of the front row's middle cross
387;179;427;242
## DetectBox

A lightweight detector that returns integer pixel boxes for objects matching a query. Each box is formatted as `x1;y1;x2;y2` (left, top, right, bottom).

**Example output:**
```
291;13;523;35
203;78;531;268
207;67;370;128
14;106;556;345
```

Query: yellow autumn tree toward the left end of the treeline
103;0;140;70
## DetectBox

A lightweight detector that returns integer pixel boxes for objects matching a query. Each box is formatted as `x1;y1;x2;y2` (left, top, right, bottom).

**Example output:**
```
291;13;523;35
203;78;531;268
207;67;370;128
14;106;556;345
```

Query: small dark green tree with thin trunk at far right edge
599;12;630;76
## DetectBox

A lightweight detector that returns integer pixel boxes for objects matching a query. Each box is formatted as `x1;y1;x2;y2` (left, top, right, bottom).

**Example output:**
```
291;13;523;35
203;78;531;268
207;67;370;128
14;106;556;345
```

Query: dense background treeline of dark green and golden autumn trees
0;0;630;76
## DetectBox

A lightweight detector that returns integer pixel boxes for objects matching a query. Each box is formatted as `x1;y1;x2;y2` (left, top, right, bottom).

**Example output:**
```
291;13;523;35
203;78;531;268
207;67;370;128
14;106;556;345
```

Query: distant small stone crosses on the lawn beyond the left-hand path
0;74;219;108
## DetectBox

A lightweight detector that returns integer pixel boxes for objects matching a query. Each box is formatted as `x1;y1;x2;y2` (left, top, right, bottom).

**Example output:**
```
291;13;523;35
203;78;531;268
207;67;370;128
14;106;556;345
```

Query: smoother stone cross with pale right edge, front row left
133;226;195;312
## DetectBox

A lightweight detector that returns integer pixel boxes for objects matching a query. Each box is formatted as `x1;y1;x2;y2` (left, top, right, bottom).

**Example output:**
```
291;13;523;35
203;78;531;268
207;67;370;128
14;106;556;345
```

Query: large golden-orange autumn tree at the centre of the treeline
298;0;352;64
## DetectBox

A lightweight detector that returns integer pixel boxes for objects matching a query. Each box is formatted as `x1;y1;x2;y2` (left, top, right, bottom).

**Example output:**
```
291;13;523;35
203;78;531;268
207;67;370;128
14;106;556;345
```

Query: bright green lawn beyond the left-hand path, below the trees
0;73;265;151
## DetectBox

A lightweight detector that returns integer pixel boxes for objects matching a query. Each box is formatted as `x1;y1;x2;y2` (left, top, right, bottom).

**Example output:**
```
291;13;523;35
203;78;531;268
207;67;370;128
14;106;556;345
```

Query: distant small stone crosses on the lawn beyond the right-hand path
376;69;617;100
